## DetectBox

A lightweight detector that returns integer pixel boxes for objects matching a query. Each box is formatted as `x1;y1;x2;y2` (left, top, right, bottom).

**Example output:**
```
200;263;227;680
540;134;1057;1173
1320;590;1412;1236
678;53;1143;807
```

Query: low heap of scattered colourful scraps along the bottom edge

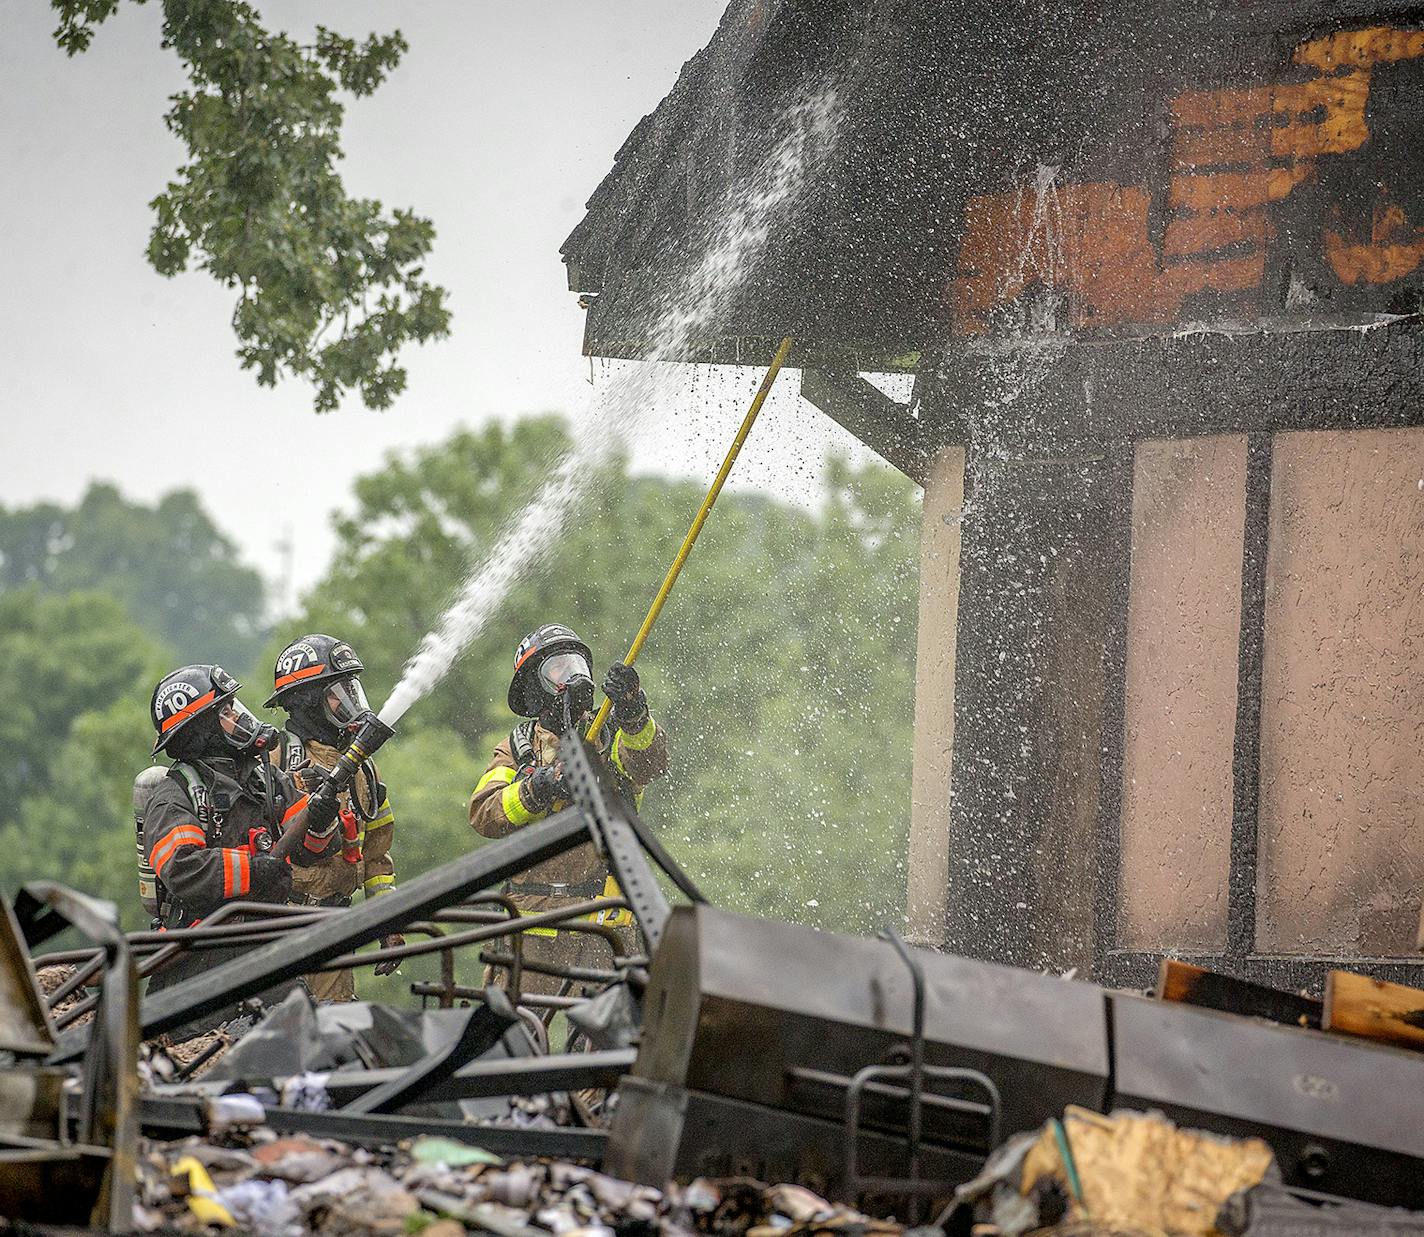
134;1127;904;1237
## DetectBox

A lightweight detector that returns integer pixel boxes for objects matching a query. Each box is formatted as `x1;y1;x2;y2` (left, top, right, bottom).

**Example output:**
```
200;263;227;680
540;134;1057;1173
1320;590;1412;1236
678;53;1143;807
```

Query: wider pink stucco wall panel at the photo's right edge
1257;430;1424;955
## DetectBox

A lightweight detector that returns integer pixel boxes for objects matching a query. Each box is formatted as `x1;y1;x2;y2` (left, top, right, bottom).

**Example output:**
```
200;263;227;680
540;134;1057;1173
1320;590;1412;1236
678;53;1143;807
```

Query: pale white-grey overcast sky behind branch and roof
0;0;888;600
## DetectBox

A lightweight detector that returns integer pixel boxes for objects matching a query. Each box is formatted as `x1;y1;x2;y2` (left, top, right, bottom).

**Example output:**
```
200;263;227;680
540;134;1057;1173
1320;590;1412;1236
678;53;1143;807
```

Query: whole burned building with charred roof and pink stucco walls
564;0;1424;985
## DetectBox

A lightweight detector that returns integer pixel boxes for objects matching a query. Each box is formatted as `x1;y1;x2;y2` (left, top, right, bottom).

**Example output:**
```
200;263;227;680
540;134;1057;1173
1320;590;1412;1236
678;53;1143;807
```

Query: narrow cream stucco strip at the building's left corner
906;447;964;947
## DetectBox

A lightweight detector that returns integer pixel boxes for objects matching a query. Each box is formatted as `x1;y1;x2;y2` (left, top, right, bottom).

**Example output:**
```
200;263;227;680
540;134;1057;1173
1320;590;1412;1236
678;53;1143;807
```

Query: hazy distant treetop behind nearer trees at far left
0;484;266;670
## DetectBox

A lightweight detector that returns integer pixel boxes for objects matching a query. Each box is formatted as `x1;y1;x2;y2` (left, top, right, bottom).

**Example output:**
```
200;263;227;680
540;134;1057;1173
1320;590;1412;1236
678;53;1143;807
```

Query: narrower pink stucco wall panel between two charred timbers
1119;436;1246;949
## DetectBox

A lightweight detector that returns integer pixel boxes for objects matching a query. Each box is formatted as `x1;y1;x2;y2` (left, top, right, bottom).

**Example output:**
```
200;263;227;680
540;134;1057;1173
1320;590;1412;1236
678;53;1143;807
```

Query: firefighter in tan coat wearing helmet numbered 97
266;633;406;1001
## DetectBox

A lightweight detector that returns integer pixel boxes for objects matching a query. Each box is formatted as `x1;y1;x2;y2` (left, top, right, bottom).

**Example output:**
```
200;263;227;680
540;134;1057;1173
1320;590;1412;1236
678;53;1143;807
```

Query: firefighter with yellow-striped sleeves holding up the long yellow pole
470;623;668;995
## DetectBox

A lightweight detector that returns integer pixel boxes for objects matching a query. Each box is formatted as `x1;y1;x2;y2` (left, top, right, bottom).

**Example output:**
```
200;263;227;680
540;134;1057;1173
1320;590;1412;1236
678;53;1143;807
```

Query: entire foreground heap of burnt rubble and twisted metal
0;752;1424;1237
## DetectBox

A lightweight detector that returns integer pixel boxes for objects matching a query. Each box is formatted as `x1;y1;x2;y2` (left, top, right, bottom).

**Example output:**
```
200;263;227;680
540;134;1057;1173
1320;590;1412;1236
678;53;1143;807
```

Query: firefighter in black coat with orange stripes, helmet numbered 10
144;665;330;992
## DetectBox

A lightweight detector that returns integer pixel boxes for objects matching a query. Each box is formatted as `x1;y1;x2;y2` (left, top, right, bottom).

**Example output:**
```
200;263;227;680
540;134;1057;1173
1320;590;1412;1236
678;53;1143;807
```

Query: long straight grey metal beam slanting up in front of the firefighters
53;809;590;1062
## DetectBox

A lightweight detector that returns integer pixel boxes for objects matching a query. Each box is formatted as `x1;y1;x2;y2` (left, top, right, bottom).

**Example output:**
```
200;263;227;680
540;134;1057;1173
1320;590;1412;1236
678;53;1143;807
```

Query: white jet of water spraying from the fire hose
380;88;839;726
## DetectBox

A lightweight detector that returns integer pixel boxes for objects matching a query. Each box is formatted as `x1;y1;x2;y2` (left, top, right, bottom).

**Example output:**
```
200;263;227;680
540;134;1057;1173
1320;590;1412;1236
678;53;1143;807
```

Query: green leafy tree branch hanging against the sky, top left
51;0;450;411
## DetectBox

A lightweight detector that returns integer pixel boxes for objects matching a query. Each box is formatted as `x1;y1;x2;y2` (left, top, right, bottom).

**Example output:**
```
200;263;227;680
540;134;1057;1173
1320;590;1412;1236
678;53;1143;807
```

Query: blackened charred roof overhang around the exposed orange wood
564;0;1424;370
